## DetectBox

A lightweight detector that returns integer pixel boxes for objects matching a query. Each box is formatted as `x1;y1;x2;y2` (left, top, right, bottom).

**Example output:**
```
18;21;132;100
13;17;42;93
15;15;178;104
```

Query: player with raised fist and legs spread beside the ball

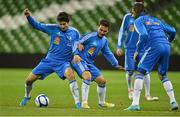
20;9;81;109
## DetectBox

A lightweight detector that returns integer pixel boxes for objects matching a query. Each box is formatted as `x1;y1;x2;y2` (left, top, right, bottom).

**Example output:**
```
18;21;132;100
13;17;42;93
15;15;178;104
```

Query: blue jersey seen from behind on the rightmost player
134;15;176;52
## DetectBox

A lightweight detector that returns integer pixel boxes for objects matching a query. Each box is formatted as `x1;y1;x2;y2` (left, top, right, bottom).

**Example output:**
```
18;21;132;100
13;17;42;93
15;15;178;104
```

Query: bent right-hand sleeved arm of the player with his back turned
161;22;176;42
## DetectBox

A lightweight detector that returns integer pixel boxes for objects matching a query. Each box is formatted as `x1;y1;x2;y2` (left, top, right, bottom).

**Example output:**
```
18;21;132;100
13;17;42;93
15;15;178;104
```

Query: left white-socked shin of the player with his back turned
132;74;144;105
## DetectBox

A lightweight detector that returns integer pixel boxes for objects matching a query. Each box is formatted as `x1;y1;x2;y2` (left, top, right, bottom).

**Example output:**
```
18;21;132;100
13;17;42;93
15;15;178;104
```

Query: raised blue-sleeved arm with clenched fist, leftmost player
24;9;52;34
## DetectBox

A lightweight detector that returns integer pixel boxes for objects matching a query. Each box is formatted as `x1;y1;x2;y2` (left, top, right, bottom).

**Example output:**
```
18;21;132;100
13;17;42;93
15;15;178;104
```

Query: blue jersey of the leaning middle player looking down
75;32;118;68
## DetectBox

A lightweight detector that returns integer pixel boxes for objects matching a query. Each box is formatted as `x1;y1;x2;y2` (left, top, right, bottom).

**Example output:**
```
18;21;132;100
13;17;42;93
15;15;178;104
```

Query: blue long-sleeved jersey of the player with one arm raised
27;16;80;63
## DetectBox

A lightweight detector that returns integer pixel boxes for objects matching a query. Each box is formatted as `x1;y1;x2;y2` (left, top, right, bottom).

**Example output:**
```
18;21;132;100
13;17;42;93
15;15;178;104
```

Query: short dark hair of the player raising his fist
57;12;70;23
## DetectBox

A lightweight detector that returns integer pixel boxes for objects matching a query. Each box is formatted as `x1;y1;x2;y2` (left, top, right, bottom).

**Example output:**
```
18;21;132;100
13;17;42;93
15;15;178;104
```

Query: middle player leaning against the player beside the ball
72;20;122;108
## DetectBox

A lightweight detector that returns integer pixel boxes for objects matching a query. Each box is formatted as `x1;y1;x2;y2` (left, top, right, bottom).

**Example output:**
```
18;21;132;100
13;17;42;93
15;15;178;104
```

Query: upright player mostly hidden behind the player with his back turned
116;1;159;101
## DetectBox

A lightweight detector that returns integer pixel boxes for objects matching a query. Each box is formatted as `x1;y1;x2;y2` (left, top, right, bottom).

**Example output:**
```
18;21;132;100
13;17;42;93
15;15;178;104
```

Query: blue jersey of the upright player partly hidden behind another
118;13;138;50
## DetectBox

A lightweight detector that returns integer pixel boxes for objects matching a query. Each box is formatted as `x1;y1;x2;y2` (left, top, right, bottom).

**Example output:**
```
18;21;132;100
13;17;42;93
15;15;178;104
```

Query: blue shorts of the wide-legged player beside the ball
32;59;70;80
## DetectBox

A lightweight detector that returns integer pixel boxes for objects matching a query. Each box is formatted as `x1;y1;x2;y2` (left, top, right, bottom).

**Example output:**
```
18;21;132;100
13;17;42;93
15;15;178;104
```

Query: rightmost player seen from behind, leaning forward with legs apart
125;4;179;111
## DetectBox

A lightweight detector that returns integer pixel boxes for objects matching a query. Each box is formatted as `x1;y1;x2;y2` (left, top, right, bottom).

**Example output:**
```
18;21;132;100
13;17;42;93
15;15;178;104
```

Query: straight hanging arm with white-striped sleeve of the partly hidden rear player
116;14;129;56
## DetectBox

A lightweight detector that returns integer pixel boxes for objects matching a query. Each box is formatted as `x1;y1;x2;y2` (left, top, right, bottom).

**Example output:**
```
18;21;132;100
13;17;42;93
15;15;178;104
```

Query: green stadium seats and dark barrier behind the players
0;0;180;71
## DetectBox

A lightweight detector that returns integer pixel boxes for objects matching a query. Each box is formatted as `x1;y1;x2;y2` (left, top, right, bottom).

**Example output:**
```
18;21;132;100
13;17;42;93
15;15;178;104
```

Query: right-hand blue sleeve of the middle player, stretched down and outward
101;40;119;68
